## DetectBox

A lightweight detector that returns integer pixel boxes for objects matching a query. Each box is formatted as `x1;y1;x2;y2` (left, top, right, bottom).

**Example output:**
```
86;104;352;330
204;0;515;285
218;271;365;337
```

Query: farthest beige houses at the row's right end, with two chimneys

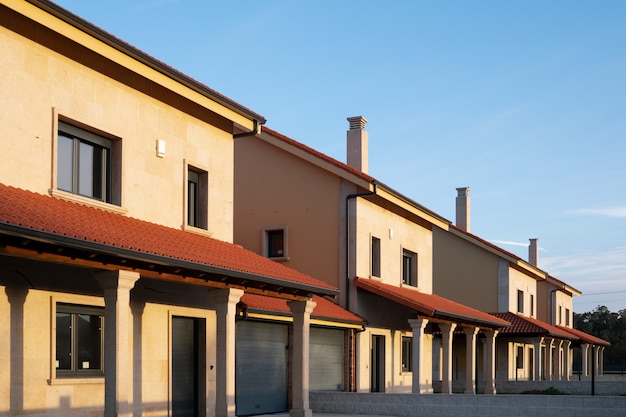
433;187;608;381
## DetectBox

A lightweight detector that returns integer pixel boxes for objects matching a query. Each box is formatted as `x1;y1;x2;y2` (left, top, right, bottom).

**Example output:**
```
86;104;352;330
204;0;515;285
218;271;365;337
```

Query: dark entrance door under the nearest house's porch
172;317;206;417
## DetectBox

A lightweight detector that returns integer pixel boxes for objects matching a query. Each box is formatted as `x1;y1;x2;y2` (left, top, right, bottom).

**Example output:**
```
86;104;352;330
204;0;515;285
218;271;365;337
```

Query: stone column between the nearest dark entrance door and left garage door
209;288;244;417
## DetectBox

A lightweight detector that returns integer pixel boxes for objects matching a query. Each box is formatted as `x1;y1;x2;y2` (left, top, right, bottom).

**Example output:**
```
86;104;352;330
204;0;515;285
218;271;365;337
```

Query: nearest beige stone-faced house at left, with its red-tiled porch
0;0;362;417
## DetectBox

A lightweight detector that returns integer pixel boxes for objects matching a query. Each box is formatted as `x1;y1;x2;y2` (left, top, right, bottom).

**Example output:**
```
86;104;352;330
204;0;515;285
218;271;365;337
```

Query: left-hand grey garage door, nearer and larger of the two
235;321;288;416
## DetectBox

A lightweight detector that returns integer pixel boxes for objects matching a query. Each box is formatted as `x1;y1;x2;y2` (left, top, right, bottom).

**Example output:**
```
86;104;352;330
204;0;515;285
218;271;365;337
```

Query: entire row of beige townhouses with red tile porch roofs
0;0;607;417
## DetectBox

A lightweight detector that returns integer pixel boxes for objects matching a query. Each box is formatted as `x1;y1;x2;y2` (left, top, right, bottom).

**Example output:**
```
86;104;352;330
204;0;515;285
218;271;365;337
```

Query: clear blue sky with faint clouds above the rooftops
57;0;626;312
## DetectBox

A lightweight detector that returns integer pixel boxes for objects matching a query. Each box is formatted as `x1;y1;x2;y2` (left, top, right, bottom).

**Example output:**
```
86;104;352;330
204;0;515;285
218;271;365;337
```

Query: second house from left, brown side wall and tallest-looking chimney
235;117;509;393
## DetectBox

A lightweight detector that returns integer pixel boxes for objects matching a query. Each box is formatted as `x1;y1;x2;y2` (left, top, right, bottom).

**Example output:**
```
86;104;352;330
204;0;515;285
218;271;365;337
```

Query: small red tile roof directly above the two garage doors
241;294;365;324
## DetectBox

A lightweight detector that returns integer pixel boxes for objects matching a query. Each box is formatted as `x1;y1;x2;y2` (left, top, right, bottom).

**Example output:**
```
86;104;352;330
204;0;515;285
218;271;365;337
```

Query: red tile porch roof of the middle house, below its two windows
354;278;509;327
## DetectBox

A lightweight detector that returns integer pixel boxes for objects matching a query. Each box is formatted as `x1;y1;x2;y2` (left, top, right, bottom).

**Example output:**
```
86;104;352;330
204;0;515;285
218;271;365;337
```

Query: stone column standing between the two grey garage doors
287;300;316;417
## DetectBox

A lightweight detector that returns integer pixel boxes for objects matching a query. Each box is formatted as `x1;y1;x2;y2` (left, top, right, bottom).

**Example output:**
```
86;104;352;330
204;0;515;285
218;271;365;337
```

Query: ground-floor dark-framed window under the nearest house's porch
56;304;104;377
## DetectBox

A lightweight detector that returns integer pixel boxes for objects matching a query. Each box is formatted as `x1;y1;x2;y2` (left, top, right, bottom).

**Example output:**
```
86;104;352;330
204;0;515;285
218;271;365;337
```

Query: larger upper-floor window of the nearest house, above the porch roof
57;122;119;205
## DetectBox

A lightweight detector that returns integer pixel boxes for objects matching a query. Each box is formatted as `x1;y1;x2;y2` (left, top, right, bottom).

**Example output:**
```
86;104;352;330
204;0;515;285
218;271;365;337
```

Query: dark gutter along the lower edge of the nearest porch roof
0;223;340;297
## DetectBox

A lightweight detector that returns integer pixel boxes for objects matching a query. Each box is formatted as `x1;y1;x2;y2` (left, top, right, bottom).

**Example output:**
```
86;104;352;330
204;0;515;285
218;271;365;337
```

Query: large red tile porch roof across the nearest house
0;184;338;294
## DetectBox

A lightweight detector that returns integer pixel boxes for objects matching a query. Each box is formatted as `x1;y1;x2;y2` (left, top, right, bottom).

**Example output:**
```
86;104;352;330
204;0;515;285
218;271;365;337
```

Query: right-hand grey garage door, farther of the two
309;327;344;391
